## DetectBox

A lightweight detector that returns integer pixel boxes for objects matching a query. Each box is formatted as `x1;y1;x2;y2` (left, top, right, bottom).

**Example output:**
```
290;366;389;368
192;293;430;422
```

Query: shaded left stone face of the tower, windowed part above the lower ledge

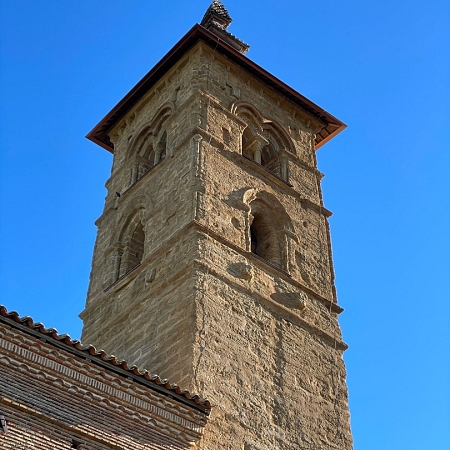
86;46;206;306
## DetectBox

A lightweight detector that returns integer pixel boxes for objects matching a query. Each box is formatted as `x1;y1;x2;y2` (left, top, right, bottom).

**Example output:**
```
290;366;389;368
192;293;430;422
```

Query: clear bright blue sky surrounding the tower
0;0;450;450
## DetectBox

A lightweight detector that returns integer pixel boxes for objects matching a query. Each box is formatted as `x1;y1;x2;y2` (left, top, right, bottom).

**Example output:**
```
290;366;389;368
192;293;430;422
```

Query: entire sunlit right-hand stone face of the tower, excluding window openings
184;48;352;450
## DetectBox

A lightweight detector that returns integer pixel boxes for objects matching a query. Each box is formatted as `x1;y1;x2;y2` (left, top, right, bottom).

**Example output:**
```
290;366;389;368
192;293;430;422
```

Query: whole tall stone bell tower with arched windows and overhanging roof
80;0;352;450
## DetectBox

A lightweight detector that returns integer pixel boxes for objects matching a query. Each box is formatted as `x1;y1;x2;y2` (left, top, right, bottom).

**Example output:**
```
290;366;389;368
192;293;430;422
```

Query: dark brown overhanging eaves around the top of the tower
86;24;347;153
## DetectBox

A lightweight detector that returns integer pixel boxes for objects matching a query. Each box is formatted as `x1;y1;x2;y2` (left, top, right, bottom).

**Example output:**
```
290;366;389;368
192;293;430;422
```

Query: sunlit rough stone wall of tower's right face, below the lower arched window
188;236;352;450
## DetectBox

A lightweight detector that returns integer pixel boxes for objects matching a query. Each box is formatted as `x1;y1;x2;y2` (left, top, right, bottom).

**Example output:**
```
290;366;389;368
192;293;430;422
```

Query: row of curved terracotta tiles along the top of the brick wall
0;305;211;413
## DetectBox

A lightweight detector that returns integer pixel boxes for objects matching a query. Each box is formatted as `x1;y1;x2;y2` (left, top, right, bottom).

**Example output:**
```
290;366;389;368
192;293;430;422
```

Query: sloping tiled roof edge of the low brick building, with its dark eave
0;305;211;414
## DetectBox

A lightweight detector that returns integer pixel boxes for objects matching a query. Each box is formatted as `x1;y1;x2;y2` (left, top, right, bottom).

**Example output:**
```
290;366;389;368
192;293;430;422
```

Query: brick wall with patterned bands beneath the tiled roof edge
0;322;205;450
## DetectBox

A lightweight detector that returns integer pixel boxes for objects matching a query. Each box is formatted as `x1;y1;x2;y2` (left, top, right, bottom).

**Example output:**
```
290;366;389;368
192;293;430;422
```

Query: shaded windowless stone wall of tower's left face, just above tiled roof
83;230;197;385
